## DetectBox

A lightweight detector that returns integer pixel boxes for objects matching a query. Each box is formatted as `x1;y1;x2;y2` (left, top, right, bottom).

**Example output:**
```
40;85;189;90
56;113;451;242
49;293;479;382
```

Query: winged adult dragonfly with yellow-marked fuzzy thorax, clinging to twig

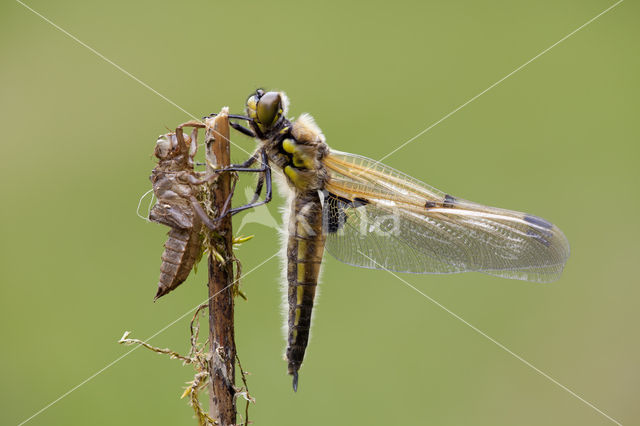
205;89;570;391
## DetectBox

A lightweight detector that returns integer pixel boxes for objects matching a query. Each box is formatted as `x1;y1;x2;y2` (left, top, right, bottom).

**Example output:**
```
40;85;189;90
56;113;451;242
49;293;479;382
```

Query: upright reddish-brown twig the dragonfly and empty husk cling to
205;108;236;426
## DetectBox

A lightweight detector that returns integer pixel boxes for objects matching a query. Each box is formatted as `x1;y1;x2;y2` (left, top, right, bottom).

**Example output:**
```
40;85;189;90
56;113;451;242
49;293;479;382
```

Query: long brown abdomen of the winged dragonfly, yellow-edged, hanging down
287;191;325;389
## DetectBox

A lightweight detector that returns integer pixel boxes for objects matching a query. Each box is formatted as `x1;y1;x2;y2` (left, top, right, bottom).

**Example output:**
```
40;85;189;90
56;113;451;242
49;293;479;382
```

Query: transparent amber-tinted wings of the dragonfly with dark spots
323;150;569;282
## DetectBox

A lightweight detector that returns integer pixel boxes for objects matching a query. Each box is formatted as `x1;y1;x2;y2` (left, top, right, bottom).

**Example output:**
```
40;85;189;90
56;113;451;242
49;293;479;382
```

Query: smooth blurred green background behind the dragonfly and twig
0;0;640;426
